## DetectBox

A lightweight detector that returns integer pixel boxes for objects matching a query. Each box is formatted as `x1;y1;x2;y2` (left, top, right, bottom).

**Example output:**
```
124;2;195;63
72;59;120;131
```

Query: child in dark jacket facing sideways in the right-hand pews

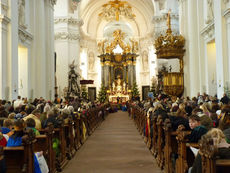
188;115;208;143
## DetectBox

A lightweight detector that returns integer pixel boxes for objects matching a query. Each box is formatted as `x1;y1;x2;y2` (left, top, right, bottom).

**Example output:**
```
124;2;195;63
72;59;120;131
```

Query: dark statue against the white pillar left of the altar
68;61;80;96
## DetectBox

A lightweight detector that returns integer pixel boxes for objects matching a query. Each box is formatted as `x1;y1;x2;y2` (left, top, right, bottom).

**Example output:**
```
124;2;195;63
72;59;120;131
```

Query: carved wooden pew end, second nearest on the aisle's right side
176;127;196;173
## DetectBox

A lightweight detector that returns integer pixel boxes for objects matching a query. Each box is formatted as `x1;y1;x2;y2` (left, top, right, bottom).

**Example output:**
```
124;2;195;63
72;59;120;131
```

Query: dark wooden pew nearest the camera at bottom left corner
3;136;34;173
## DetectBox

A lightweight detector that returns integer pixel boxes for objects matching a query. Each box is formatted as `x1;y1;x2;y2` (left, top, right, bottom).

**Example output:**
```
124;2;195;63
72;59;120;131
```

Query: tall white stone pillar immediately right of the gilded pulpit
179;0;200;96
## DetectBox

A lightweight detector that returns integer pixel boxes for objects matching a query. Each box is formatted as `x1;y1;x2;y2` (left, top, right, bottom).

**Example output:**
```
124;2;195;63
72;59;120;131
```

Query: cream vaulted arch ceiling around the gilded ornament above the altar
80;0;154;39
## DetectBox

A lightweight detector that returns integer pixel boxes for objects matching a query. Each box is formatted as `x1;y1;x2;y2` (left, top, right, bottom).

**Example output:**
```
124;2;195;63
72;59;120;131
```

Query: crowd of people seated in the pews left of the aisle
0;96;107;173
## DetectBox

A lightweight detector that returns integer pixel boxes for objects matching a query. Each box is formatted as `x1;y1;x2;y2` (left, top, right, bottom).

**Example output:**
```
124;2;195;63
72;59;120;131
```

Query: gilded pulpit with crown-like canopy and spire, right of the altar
155;12;185;96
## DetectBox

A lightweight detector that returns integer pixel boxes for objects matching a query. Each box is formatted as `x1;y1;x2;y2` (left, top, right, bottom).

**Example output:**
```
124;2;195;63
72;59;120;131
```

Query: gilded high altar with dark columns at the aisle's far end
98;30;138;102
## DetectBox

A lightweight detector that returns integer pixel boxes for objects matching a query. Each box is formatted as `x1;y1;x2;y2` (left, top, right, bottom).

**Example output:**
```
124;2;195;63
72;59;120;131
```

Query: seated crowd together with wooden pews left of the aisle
0;96;107;173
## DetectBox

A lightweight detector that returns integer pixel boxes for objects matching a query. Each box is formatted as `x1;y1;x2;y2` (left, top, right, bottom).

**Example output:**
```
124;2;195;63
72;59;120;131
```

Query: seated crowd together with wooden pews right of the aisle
128;93;230;173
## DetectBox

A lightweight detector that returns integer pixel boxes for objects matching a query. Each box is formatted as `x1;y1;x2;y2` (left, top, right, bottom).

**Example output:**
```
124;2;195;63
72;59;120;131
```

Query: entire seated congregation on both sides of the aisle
0;93;230;173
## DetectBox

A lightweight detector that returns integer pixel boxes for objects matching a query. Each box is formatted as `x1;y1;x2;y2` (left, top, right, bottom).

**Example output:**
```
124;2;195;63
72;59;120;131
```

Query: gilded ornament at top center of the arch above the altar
99;0;136;21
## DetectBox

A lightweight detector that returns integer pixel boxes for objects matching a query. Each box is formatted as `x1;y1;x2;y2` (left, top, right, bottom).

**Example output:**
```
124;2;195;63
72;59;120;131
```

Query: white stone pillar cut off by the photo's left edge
0;0;10;100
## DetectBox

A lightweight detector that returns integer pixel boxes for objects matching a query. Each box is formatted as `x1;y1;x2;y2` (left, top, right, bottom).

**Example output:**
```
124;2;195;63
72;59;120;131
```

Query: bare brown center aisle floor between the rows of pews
63;111;161;173
